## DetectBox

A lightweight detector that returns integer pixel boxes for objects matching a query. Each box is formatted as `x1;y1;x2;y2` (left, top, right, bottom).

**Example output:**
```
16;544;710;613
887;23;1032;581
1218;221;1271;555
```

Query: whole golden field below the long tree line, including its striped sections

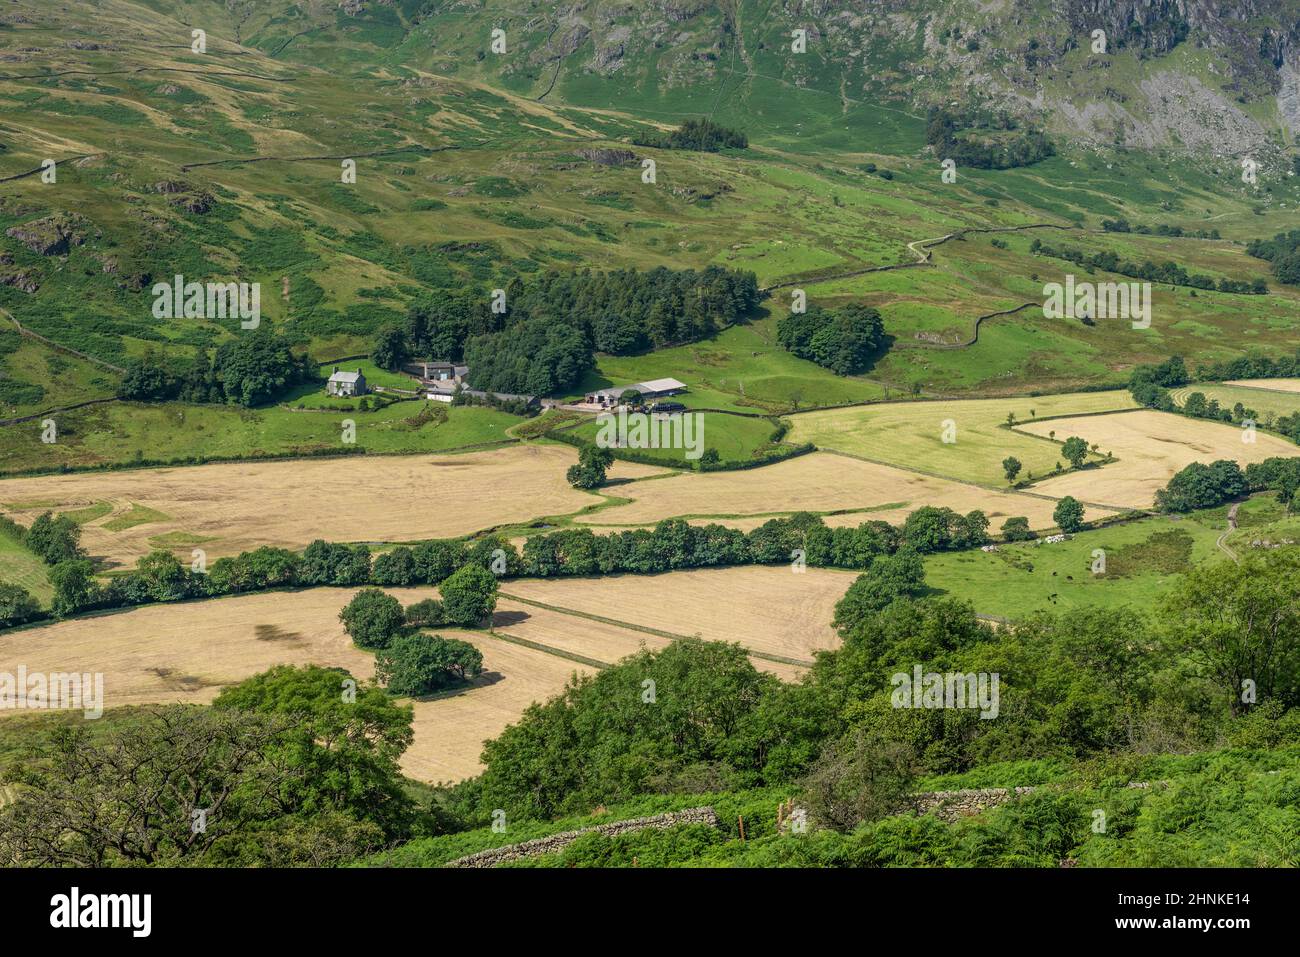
0;568;821;781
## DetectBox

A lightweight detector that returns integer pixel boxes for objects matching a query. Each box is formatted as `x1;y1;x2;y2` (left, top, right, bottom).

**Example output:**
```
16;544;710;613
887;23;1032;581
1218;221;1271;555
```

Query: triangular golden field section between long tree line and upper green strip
502;566;857;662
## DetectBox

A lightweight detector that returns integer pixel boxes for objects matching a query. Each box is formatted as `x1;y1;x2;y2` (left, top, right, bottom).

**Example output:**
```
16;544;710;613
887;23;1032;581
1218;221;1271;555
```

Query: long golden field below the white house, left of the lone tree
0;445;663;567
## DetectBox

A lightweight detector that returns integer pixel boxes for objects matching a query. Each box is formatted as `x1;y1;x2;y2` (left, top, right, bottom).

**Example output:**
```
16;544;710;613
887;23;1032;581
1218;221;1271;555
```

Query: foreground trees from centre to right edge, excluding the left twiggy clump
450;550;1300;832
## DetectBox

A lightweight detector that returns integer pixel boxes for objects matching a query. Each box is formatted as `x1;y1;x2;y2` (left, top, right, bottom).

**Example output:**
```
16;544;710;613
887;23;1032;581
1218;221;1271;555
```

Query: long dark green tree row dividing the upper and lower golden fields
15;506;1055;627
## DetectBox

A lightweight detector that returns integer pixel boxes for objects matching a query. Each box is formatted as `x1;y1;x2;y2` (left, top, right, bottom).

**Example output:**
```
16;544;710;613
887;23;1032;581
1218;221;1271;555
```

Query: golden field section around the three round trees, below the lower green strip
0;588;592;781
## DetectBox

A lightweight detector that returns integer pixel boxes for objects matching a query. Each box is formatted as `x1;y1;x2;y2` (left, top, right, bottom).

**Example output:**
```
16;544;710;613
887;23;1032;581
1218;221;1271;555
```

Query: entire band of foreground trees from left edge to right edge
10;550;1300;867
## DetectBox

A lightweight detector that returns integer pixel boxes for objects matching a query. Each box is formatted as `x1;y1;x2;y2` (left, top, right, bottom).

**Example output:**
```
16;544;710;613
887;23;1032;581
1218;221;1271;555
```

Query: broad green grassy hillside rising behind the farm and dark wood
0;1;1297;403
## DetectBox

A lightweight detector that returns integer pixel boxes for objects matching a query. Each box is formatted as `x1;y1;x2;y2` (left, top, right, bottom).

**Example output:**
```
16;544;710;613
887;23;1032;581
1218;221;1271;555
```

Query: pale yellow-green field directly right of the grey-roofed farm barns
787;391;1136;486
